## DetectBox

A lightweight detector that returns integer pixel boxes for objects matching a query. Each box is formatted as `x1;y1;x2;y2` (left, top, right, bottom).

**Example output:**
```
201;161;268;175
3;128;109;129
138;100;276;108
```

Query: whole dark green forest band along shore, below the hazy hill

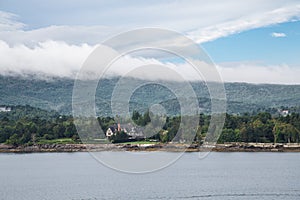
0;106;300;146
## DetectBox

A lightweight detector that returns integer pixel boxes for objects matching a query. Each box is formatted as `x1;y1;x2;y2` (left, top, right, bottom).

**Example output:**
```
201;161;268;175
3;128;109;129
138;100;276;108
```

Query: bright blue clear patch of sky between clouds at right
202;21;300;66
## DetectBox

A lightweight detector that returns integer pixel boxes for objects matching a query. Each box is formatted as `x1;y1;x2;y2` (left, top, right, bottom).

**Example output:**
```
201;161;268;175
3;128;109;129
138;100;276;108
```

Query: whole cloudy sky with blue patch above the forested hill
0;0;300;84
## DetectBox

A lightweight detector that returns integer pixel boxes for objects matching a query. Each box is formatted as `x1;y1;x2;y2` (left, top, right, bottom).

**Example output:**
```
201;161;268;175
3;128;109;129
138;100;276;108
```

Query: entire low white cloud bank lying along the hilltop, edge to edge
0;41;300;84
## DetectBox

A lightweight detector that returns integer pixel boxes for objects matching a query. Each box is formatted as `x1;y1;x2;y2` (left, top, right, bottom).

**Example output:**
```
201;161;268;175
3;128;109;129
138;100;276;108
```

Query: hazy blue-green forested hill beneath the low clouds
0;76;300;116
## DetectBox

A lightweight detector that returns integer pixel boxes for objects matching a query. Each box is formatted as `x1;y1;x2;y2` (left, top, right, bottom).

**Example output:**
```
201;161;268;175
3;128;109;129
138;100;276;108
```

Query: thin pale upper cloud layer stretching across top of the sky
0;0;300;45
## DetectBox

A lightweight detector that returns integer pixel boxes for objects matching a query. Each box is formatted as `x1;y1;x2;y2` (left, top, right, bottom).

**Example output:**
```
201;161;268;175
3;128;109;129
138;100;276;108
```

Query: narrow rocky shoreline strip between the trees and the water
0;143;300;153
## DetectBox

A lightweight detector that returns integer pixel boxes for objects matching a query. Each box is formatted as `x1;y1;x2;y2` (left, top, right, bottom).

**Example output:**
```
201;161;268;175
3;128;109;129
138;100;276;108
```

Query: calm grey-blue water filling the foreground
0;152;300;200
